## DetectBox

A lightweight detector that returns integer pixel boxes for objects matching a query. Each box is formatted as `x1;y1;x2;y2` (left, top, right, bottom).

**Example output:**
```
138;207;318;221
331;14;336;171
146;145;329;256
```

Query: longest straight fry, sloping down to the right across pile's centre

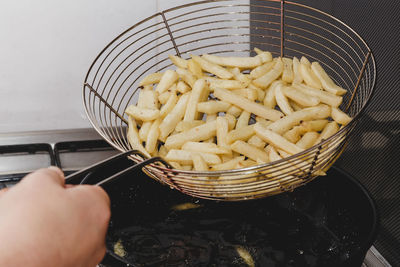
214;88;283;121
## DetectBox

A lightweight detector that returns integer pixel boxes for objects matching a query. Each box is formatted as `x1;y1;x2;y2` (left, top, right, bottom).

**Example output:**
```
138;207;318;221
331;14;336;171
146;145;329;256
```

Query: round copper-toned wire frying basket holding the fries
83;0;376;201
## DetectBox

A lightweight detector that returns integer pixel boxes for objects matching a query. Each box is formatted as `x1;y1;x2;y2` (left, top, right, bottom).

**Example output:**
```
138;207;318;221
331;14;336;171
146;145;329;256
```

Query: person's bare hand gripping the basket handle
0;167;110;267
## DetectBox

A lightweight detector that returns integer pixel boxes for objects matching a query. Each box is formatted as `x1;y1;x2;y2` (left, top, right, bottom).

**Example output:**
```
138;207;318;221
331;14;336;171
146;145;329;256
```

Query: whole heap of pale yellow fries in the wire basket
126;48;351;171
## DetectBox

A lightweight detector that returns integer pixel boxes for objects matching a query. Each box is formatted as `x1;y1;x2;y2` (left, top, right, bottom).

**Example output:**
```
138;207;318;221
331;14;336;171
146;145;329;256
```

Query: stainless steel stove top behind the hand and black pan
0;129;390;267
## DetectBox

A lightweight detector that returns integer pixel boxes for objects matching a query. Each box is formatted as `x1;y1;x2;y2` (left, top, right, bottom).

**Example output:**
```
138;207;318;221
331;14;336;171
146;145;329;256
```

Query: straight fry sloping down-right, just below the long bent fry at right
254;123;303;155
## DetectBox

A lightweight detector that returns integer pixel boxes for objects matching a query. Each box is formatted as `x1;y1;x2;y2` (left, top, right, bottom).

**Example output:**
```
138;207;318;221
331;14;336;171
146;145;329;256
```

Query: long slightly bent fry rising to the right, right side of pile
268;105;331;134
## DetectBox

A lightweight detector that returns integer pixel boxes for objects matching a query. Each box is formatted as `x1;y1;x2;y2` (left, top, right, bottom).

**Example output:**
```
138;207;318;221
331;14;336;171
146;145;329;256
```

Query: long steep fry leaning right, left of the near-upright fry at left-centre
160;93;190;141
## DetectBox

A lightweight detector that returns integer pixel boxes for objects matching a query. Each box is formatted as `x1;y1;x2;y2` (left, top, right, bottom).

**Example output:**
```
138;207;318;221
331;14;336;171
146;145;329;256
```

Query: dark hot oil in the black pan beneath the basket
108;171;366;267
